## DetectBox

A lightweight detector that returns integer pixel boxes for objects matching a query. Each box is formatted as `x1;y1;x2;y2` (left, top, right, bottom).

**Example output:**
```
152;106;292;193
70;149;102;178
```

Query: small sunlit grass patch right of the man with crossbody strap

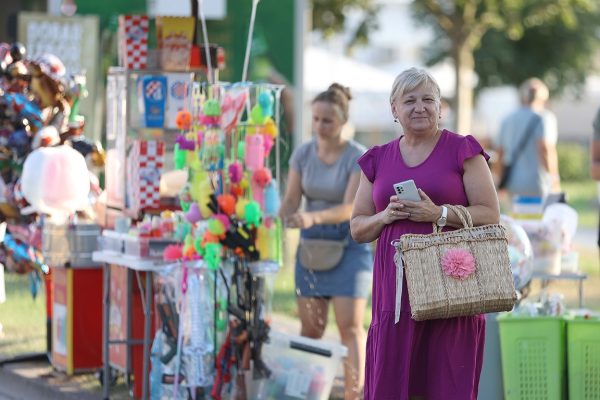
561;179;598;228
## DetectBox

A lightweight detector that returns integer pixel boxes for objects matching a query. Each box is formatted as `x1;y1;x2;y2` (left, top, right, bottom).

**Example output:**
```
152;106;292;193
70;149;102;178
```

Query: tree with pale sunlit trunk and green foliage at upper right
412;0;600;131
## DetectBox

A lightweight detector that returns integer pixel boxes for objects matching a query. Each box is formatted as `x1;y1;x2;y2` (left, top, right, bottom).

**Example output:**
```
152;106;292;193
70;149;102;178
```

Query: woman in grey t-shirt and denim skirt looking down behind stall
280;83;372;399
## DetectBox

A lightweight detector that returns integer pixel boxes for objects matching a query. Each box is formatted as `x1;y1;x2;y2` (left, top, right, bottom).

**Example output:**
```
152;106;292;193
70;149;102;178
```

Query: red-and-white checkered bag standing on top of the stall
119;15;149;69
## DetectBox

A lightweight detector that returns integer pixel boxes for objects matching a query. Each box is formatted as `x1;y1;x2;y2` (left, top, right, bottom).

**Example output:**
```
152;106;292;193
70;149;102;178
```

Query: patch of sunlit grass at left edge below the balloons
0;272;46;358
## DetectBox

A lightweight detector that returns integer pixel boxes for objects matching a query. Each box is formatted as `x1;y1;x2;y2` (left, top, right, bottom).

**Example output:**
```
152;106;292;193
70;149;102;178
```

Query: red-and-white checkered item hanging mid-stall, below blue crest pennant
127;140;165;213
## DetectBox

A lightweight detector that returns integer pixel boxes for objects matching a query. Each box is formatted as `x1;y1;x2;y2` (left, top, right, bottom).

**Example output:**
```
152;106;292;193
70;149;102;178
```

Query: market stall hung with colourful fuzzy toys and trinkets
93;4;345;399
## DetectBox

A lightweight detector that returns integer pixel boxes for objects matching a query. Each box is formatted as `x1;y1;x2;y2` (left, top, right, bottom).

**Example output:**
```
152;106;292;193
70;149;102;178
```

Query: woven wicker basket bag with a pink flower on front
393;205;517;321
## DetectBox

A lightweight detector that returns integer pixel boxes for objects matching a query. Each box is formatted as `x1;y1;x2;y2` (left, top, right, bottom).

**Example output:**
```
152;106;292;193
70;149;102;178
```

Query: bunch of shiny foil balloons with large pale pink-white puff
0;43;104;272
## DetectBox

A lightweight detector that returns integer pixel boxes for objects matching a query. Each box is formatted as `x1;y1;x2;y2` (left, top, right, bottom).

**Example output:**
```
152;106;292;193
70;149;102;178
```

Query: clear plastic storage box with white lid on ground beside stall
246;332;348;400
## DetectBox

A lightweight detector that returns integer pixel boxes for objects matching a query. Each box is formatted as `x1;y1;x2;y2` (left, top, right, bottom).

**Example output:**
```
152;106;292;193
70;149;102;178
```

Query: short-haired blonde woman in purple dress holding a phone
350;68;500;400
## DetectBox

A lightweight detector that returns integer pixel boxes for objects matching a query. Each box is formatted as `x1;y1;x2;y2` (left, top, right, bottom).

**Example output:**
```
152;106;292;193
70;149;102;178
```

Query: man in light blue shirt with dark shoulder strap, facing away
494;78;560;198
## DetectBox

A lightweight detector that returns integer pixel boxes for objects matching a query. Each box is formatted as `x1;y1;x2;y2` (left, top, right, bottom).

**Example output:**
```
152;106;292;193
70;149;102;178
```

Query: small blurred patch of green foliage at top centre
311;0;379;47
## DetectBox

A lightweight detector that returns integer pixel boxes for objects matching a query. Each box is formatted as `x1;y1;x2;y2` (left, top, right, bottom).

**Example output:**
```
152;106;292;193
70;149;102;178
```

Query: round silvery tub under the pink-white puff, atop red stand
42;223;100;267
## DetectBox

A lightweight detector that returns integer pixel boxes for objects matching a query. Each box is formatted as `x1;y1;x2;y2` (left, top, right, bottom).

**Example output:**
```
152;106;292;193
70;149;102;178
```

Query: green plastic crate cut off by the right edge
567;317;600;400
